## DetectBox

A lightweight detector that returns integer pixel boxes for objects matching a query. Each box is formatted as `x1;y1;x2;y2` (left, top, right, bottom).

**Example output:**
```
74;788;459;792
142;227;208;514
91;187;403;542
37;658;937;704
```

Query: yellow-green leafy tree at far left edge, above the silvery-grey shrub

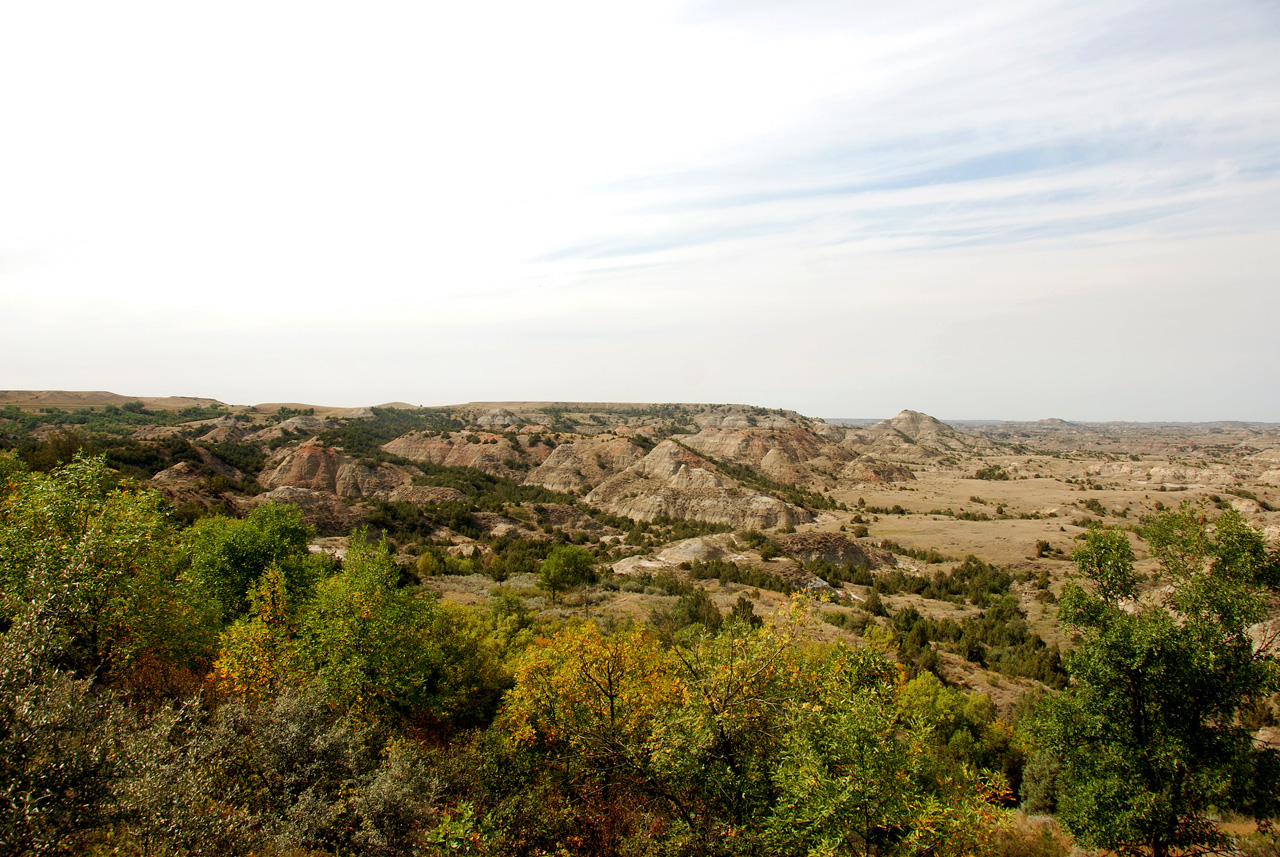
0;455;212;683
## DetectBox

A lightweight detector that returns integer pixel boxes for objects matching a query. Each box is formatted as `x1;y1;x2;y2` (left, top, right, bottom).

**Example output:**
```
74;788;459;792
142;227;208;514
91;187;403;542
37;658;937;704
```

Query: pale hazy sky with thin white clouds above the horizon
0;0;1280;422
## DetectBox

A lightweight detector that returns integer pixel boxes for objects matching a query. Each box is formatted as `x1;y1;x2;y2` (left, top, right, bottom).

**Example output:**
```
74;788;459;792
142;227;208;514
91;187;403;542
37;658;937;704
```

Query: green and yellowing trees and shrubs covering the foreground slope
0;452;1280;857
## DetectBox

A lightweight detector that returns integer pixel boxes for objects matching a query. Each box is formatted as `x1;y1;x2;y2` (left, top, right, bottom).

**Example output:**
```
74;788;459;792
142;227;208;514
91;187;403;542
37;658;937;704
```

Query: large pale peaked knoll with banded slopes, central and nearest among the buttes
586;440;813;528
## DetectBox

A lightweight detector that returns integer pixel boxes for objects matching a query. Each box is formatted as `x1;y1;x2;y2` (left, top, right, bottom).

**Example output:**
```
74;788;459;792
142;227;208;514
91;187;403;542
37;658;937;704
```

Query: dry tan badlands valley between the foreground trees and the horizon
0;391;1280;709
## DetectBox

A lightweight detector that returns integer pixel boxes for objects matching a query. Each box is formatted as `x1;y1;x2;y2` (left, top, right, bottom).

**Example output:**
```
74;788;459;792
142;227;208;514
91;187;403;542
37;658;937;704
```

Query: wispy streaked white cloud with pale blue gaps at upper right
524;4;1280;268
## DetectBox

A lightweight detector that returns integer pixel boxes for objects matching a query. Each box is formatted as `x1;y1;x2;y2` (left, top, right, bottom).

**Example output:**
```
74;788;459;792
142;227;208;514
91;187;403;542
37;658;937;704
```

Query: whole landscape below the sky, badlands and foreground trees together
0;391;1280;857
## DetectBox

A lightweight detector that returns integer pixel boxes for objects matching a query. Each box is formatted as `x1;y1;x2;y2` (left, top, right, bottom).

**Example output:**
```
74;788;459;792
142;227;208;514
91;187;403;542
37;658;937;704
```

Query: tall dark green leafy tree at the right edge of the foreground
1032;504;1280;857
